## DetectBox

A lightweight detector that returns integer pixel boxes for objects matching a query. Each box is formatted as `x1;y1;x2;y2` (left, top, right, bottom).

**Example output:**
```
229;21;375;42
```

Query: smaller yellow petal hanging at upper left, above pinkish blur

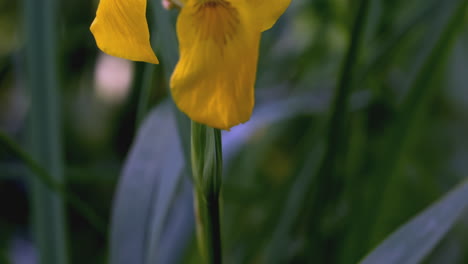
91;0;159;63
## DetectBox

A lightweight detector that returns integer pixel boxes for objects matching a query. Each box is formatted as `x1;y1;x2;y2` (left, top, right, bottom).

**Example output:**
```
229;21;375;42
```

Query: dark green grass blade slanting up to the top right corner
371;0;468;243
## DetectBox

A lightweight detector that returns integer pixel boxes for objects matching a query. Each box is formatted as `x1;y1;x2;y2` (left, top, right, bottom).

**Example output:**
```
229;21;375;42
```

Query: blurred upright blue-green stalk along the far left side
24;0;68;264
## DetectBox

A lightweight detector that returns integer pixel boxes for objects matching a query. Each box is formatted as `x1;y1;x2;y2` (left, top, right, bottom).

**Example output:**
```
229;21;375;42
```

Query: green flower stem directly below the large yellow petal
191;121;223;264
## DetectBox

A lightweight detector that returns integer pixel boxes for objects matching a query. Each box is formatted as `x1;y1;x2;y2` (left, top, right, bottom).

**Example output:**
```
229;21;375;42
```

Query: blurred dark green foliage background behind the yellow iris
0;0;468;264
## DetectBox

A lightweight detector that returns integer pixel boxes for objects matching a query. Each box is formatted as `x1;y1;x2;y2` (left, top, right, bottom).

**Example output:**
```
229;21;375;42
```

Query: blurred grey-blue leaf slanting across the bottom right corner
361;181;468;264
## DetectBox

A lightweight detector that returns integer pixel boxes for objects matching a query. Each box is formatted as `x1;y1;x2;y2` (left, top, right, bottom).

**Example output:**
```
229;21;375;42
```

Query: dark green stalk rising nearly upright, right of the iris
307;0;371;262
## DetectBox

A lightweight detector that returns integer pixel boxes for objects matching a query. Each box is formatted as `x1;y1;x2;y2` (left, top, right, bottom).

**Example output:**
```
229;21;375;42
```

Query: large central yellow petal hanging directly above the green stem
171;0;261;129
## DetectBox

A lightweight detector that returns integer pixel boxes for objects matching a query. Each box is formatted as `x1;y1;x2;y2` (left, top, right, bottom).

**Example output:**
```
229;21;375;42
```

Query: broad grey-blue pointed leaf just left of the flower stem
110;102;193;264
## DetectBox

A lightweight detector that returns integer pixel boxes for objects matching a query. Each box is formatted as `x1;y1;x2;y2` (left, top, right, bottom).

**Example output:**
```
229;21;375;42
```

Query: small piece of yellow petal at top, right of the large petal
240;0;291;31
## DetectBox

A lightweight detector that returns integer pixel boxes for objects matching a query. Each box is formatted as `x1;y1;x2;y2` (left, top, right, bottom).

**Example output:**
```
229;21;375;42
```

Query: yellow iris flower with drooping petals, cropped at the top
91;0;291;129
